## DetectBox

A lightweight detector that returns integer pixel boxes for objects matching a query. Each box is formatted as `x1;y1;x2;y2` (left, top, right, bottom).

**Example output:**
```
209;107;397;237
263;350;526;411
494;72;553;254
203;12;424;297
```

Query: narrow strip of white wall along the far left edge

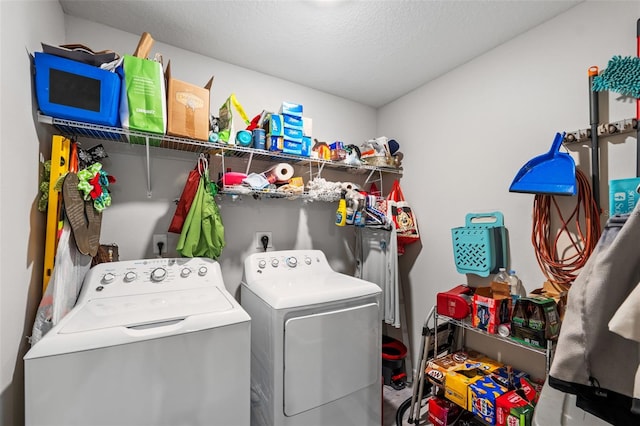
0;1;65;425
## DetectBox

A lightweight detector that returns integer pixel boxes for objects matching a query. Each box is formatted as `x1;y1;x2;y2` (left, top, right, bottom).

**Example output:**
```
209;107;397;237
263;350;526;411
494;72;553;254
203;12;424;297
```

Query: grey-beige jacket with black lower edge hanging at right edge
549;204;640;425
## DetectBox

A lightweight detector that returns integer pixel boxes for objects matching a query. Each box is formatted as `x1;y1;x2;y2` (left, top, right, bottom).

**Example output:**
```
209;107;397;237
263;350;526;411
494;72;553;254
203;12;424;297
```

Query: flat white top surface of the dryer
242;272;382;309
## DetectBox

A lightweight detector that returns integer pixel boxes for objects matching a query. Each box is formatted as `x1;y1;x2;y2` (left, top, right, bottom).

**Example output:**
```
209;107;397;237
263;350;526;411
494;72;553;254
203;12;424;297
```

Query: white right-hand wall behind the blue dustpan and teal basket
377;1;640;380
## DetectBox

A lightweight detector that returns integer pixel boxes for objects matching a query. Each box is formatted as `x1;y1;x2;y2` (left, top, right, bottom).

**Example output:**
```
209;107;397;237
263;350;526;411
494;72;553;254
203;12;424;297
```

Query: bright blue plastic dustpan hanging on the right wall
509;133;577;195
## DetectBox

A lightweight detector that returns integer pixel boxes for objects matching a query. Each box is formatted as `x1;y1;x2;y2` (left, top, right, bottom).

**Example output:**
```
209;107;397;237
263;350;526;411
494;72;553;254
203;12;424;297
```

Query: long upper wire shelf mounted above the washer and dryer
38;113;402;198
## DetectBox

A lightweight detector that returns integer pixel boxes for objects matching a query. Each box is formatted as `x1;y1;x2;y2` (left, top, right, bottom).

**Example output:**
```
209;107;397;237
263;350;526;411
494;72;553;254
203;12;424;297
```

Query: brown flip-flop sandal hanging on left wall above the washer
62;172;102;257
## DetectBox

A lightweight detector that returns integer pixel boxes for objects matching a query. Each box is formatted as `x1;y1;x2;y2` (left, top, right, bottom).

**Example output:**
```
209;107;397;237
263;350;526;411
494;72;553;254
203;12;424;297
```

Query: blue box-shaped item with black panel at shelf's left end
34;52;121;126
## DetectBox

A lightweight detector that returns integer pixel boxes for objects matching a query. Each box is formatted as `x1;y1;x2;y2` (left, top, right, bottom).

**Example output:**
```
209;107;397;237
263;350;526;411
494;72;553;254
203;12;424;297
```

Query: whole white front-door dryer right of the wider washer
240;250;382;426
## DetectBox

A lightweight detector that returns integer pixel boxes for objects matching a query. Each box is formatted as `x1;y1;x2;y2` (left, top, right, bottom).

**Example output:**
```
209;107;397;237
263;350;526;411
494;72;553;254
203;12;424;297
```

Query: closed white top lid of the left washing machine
59;286;234;334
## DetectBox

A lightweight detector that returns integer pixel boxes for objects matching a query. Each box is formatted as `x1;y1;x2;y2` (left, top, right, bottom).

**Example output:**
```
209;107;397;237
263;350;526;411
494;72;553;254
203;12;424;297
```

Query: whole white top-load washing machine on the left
24;258;251;426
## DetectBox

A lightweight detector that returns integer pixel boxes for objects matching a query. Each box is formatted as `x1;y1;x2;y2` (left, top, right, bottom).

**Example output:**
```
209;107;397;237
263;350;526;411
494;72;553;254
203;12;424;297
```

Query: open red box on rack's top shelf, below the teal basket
472;282;512;334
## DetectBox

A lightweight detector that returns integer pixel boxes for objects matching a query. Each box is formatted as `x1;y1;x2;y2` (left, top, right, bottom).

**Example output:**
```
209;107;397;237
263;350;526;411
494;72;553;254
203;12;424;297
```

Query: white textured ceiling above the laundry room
59;0;583;107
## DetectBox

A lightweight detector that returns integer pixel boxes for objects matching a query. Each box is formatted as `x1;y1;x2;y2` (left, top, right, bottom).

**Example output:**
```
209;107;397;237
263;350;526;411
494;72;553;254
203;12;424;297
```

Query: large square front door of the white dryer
283;303;382;416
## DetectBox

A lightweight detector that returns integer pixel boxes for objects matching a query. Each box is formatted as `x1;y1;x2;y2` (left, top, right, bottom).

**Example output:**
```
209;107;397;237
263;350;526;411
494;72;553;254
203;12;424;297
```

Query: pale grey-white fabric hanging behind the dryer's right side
355;226;400;328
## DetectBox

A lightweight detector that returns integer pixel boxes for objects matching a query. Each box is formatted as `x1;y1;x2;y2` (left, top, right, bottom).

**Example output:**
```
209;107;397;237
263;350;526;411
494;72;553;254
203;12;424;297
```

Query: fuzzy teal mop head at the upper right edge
591;55;640;99
